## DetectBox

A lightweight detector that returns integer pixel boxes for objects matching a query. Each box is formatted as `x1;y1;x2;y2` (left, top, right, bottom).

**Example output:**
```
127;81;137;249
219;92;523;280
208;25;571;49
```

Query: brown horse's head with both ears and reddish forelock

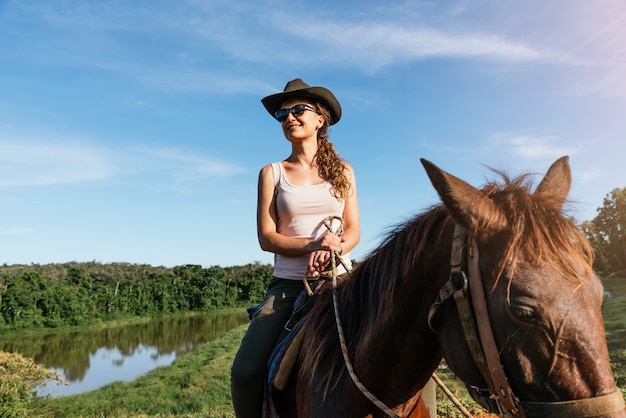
422;157;626;417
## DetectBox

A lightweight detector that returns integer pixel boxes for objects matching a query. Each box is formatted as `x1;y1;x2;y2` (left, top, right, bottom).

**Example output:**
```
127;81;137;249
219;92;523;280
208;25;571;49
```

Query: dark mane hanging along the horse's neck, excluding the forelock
300;205;453;393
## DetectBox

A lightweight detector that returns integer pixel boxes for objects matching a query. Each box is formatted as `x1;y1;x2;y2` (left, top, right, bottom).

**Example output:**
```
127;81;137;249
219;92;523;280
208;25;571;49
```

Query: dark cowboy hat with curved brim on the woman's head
261;78;341;125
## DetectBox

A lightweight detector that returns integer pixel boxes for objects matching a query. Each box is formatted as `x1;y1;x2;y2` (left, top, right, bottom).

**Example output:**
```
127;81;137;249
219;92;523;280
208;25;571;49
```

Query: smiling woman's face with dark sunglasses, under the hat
280;99;324;141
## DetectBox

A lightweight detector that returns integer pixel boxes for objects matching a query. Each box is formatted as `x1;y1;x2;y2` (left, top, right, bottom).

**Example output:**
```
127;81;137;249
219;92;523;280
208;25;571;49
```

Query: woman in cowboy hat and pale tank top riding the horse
231;79;361;418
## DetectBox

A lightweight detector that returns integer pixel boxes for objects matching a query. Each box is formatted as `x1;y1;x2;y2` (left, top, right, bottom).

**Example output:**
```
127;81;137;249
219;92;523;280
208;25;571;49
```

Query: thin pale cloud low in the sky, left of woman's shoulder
0;140;246;188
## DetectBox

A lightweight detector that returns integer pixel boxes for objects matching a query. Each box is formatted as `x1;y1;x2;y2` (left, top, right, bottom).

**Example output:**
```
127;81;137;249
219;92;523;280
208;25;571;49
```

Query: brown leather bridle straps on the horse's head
428;224;624;418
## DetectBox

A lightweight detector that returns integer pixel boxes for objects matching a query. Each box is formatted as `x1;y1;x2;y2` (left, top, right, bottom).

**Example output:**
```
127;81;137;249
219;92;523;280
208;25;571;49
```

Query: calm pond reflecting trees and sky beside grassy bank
0;309;248;397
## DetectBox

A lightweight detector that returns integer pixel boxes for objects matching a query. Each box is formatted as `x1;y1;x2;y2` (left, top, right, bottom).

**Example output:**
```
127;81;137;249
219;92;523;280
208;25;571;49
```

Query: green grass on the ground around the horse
31;278;626;418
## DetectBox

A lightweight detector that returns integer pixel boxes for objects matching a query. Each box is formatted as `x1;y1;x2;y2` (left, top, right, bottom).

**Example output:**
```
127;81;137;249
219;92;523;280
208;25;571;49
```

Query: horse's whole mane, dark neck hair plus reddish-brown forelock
300;170;593;393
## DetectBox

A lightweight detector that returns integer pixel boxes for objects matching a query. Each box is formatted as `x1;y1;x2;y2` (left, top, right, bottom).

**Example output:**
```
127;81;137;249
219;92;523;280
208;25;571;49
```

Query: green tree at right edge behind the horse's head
581;187;626;274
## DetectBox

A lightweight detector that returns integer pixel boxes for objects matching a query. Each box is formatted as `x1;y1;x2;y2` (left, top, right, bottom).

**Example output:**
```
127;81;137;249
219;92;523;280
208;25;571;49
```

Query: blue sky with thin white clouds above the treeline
0;0;626;266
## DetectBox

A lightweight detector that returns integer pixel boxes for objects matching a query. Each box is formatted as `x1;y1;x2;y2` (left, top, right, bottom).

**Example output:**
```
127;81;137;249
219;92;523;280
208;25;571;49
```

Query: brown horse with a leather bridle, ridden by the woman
278;157;626;418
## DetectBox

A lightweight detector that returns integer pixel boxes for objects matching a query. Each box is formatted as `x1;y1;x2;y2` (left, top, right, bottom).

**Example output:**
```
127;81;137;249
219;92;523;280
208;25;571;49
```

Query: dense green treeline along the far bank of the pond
0;262;273;332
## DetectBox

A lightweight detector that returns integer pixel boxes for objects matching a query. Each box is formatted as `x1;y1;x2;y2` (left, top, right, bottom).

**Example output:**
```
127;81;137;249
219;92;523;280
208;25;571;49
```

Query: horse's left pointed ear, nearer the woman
420;158;507;236
